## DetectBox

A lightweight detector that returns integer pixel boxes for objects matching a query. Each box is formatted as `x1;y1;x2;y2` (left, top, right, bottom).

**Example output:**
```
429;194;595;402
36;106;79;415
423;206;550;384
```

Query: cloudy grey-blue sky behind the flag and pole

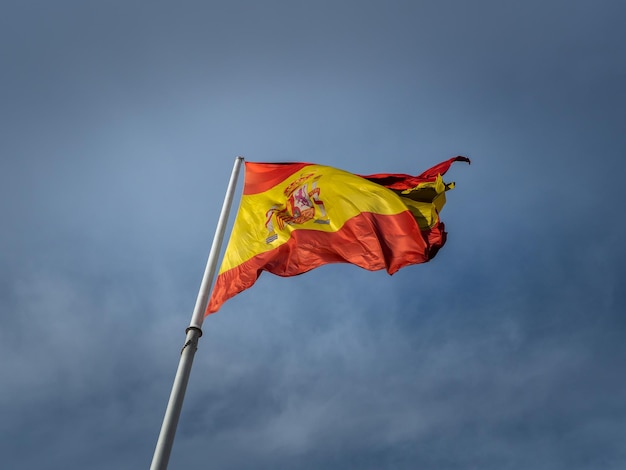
0;0;626;470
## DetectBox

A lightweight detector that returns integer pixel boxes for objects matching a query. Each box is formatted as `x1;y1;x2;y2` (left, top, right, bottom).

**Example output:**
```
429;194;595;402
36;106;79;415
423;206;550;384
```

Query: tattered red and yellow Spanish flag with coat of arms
206;157;469;315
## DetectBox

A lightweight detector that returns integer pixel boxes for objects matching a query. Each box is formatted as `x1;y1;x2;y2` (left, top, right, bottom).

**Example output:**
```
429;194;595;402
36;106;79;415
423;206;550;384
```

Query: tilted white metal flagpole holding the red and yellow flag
150;157;243;470
